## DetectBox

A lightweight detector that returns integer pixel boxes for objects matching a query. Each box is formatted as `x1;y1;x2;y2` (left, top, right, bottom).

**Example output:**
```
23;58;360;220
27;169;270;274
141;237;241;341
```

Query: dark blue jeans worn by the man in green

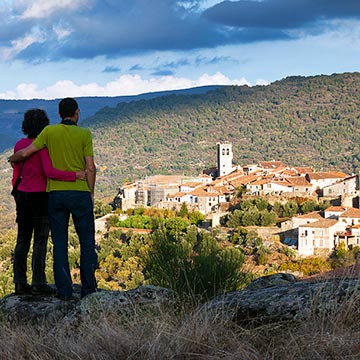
48;190;97;297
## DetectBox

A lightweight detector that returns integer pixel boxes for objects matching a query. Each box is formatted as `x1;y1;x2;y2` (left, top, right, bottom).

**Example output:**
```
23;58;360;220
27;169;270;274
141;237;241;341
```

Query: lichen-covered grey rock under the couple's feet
0;285;174;323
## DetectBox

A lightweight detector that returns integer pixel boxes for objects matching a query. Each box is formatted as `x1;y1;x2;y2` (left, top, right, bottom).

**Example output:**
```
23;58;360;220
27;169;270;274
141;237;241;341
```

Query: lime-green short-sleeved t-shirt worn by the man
33;124;94;191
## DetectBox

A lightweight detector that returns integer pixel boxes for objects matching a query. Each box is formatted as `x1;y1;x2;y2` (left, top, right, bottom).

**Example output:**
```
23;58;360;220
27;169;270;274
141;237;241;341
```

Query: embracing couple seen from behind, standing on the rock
8;98;97;300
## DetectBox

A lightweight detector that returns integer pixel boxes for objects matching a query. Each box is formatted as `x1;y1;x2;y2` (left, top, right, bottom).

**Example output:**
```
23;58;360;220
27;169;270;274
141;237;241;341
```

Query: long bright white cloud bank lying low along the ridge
0;72;250;99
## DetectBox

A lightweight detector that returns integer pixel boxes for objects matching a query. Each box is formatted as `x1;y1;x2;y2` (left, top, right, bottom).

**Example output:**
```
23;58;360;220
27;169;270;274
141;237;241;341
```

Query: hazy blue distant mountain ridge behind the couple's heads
0;85;220;152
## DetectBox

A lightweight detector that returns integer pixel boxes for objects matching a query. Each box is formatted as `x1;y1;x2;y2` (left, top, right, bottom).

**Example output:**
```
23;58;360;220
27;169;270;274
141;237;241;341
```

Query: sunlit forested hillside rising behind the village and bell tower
83;73;360;193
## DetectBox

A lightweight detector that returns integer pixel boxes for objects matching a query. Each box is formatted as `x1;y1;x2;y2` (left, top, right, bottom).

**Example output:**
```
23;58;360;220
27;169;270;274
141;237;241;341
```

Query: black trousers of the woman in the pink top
14;191;49;285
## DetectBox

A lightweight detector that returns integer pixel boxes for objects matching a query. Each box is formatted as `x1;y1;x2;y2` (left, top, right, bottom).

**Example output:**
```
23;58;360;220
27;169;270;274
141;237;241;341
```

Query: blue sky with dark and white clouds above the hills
0;0;360;99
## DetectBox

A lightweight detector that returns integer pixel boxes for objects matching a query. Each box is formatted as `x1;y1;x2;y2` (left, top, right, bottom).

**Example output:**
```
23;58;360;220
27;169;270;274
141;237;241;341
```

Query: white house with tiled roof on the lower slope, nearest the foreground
298;219;345;256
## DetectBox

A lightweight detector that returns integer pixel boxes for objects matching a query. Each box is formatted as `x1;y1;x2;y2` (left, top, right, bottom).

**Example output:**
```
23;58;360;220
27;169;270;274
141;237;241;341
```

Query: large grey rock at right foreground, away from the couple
201;273;360;325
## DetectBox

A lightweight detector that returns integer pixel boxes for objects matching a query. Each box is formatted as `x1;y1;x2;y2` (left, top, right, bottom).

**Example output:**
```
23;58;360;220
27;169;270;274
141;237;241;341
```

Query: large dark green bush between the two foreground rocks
143;226;245;300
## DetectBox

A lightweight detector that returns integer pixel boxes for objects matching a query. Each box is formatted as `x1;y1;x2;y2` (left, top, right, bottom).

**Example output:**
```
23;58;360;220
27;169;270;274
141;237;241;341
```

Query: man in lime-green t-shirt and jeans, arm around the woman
9;98;97;300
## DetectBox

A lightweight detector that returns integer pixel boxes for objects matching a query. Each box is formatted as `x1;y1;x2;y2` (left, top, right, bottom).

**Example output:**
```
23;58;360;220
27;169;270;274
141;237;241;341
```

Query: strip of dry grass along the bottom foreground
0;272;360;360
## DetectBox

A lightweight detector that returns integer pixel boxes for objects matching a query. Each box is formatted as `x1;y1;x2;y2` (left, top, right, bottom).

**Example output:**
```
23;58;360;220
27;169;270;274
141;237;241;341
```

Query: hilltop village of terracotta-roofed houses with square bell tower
113;142;360;256
